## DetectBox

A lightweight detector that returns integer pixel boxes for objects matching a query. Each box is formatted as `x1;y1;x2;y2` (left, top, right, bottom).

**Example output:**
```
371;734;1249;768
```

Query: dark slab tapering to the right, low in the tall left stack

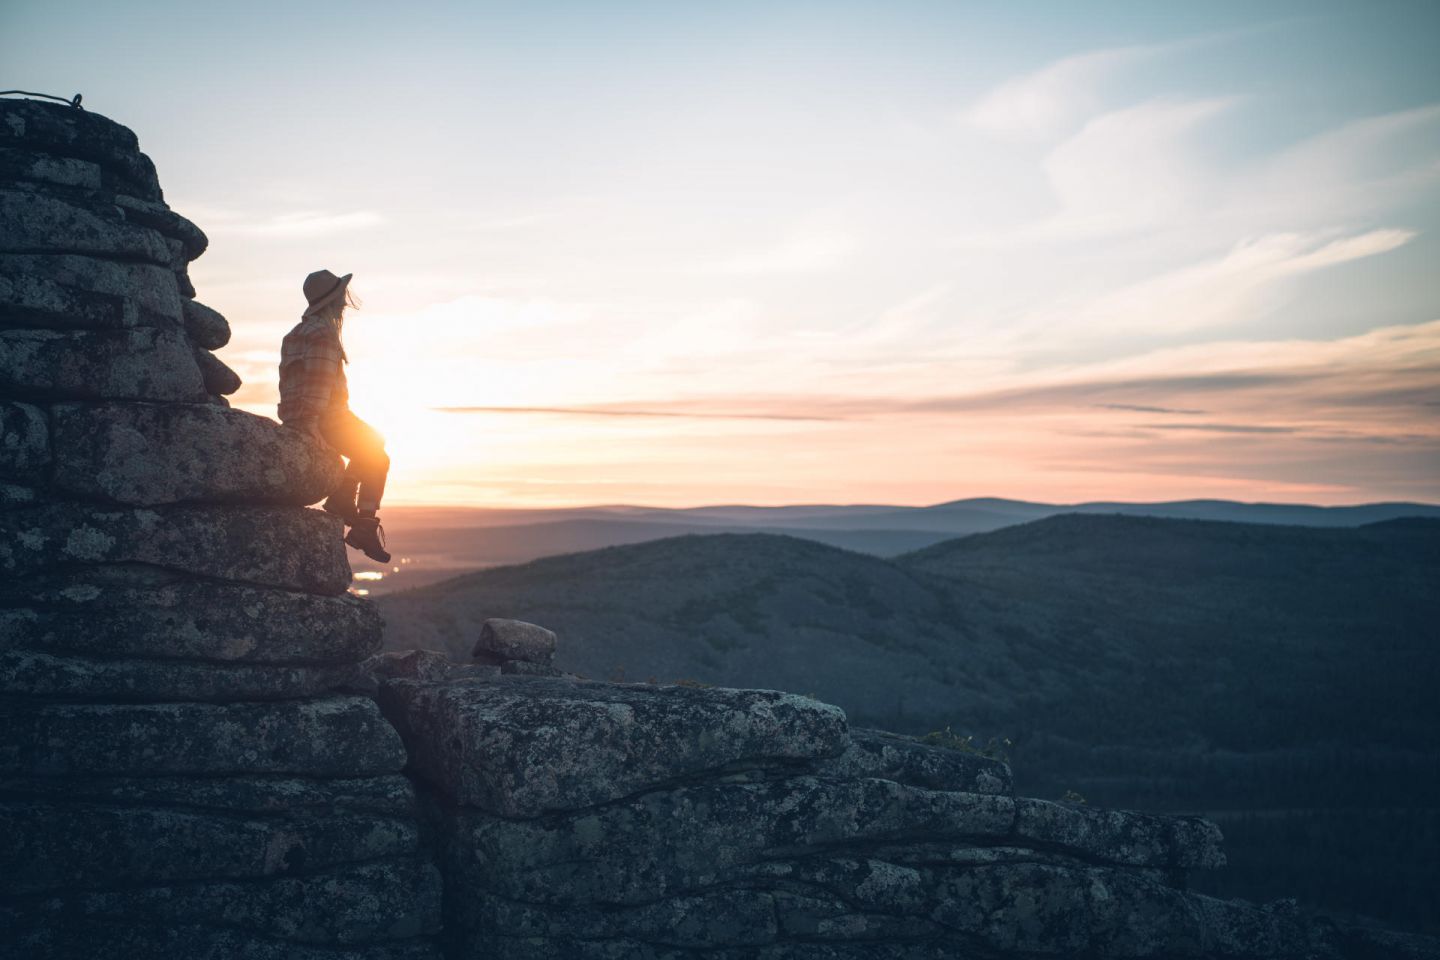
0;800;419;895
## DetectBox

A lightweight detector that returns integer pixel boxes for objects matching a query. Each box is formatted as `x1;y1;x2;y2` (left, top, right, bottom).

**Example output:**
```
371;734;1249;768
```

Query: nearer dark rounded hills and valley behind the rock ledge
380;515;1440;928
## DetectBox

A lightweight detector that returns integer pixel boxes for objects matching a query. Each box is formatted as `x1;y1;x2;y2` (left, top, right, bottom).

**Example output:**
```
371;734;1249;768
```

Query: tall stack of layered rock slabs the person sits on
0;99;441;959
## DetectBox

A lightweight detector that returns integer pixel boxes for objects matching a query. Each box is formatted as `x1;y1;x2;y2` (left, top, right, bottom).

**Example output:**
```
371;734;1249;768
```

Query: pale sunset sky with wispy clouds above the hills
0;0;1440;507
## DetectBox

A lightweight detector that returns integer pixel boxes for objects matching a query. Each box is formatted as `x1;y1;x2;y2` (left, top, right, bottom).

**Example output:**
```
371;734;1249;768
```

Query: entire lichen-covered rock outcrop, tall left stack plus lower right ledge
0;101;1440;960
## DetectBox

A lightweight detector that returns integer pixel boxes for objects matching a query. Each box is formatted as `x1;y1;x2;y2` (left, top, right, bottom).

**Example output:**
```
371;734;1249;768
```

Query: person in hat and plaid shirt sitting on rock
278;271;390;563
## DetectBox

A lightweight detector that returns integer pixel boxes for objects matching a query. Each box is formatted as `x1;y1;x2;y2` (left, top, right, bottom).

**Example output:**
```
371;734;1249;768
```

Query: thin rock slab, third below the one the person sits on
0;651;360;702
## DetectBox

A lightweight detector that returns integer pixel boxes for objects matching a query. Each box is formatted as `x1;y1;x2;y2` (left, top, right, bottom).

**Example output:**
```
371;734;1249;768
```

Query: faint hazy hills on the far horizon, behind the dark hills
353;498;1440;596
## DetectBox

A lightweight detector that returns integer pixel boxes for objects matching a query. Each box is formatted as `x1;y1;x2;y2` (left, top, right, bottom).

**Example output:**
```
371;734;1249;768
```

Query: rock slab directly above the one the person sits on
0;327;209;403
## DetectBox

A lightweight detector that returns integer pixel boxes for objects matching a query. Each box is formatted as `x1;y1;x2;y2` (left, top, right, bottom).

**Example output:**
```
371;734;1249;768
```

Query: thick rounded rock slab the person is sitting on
50;403;344;507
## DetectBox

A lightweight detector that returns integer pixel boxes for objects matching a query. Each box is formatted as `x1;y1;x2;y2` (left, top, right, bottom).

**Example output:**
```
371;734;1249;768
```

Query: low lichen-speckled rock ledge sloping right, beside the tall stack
380;676;1376;960
